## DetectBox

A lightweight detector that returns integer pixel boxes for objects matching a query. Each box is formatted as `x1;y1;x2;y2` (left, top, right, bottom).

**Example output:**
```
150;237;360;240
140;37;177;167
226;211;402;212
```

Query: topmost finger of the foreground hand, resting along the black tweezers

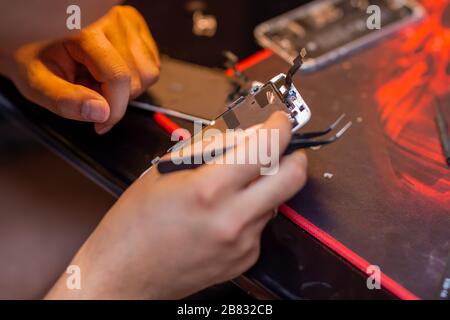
197;112;292;191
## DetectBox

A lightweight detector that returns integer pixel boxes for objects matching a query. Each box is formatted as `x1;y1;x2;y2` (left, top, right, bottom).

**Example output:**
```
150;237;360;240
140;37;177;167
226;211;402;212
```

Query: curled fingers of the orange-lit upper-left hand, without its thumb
66;6;160;134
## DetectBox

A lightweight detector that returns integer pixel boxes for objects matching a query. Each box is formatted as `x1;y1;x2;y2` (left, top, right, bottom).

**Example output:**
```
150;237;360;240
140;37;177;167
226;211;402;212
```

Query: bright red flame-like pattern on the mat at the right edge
376;0;450;203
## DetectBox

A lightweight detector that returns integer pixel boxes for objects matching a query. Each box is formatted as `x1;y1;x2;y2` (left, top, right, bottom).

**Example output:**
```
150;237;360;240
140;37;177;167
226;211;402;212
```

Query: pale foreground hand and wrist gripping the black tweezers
48;113;307;299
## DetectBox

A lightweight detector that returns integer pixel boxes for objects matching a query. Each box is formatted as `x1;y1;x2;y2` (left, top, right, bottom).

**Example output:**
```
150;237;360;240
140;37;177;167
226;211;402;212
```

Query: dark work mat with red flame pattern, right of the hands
246;1;450;298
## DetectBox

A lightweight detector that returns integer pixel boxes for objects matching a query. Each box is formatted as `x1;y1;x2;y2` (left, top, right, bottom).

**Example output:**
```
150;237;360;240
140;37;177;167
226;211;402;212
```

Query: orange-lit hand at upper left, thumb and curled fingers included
1;6;160;134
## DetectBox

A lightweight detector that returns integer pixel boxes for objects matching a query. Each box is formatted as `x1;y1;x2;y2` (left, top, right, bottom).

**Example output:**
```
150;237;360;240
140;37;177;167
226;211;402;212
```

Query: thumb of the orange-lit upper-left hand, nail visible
16;61;110;123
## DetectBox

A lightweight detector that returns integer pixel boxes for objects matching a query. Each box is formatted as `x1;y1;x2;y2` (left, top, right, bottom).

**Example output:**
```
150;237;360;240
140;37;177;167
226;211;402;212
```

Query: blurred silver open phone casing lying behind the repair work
254;0;425;71
